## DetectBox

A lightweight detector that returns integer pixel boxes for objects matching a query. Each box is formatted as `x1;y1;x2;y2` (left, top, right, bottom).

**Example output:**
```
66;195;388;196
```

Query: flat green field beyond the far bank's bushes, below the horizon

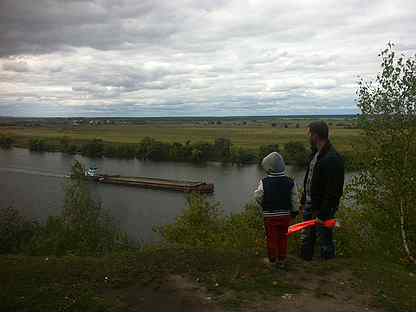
0;124;360;151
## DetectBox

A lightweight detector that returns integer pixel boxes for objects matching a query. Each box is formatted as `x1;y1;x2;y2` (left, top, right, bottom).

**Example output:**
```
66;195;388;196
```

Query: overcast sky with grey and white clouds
0;0;416;116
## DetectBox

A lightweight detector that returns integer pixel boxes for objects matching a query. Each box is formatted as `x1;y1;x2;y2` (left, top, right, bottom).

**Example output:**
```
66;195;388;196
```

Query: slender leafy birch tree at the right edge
353;44;416;261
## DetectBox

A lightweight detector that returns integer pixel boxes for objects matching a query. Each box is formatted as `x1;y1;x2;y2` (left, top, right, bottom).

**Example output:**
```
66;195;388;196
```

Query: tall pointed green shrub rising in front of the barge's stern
30;161;128;255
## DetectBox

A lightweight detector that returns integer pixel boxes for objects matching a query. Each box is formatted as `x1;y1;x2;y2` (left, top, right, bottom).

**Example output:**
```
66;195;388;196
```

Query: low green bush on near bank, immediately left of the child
158;194;264;251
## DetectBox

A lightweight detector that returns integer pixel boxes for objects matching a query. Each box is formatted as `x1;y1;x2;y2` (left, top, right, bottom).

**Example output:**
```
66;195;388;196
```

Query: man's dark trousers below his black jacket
301;207;335;260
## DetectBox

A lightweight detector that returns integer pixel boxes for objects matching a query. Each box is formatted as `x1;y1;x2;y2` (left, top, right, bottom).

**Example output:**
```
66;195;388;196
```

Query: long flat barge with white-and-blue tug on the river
85;168;214;194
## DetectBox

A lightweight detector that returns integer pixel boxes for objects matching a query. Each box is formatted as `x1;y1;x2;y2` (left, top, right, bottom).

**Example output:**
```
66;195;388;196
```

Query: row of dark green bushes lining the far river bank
0;135;360;170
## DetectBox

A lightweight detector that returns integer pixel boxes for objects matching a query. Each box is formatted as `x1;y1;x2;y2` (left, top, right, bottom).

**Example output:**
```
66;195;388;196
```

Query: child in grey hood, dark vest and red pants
254;152;299;268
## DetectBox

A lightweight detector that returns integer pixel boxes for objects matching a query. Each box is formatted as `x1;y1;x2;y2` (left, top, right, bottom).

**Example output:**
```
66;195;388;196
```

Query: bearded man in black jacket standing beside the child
301;121;344;260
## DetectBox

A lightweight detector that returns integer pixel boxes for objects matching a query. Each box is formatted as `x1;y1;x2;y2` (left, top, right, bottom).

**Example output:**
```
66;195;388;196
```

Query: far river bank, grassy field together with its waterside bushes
0;125;360;170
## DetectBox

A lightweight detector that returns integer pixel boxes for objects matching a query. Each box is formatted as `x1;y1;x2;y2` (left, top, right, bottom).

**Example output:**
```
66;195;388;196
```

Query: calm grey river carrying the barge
0;148;350;242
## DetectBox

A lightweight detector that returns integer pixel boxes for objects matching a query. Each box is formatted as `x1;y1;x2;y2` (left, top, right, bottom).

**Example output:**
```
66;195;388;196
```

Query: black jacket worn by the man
301;142;345;220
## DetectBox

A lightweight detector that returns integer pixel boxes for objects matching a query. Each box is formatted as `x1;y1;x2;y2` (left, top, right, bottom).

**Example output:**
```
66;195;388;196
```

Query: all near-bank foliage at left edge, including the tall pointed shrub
0;162;135;255
